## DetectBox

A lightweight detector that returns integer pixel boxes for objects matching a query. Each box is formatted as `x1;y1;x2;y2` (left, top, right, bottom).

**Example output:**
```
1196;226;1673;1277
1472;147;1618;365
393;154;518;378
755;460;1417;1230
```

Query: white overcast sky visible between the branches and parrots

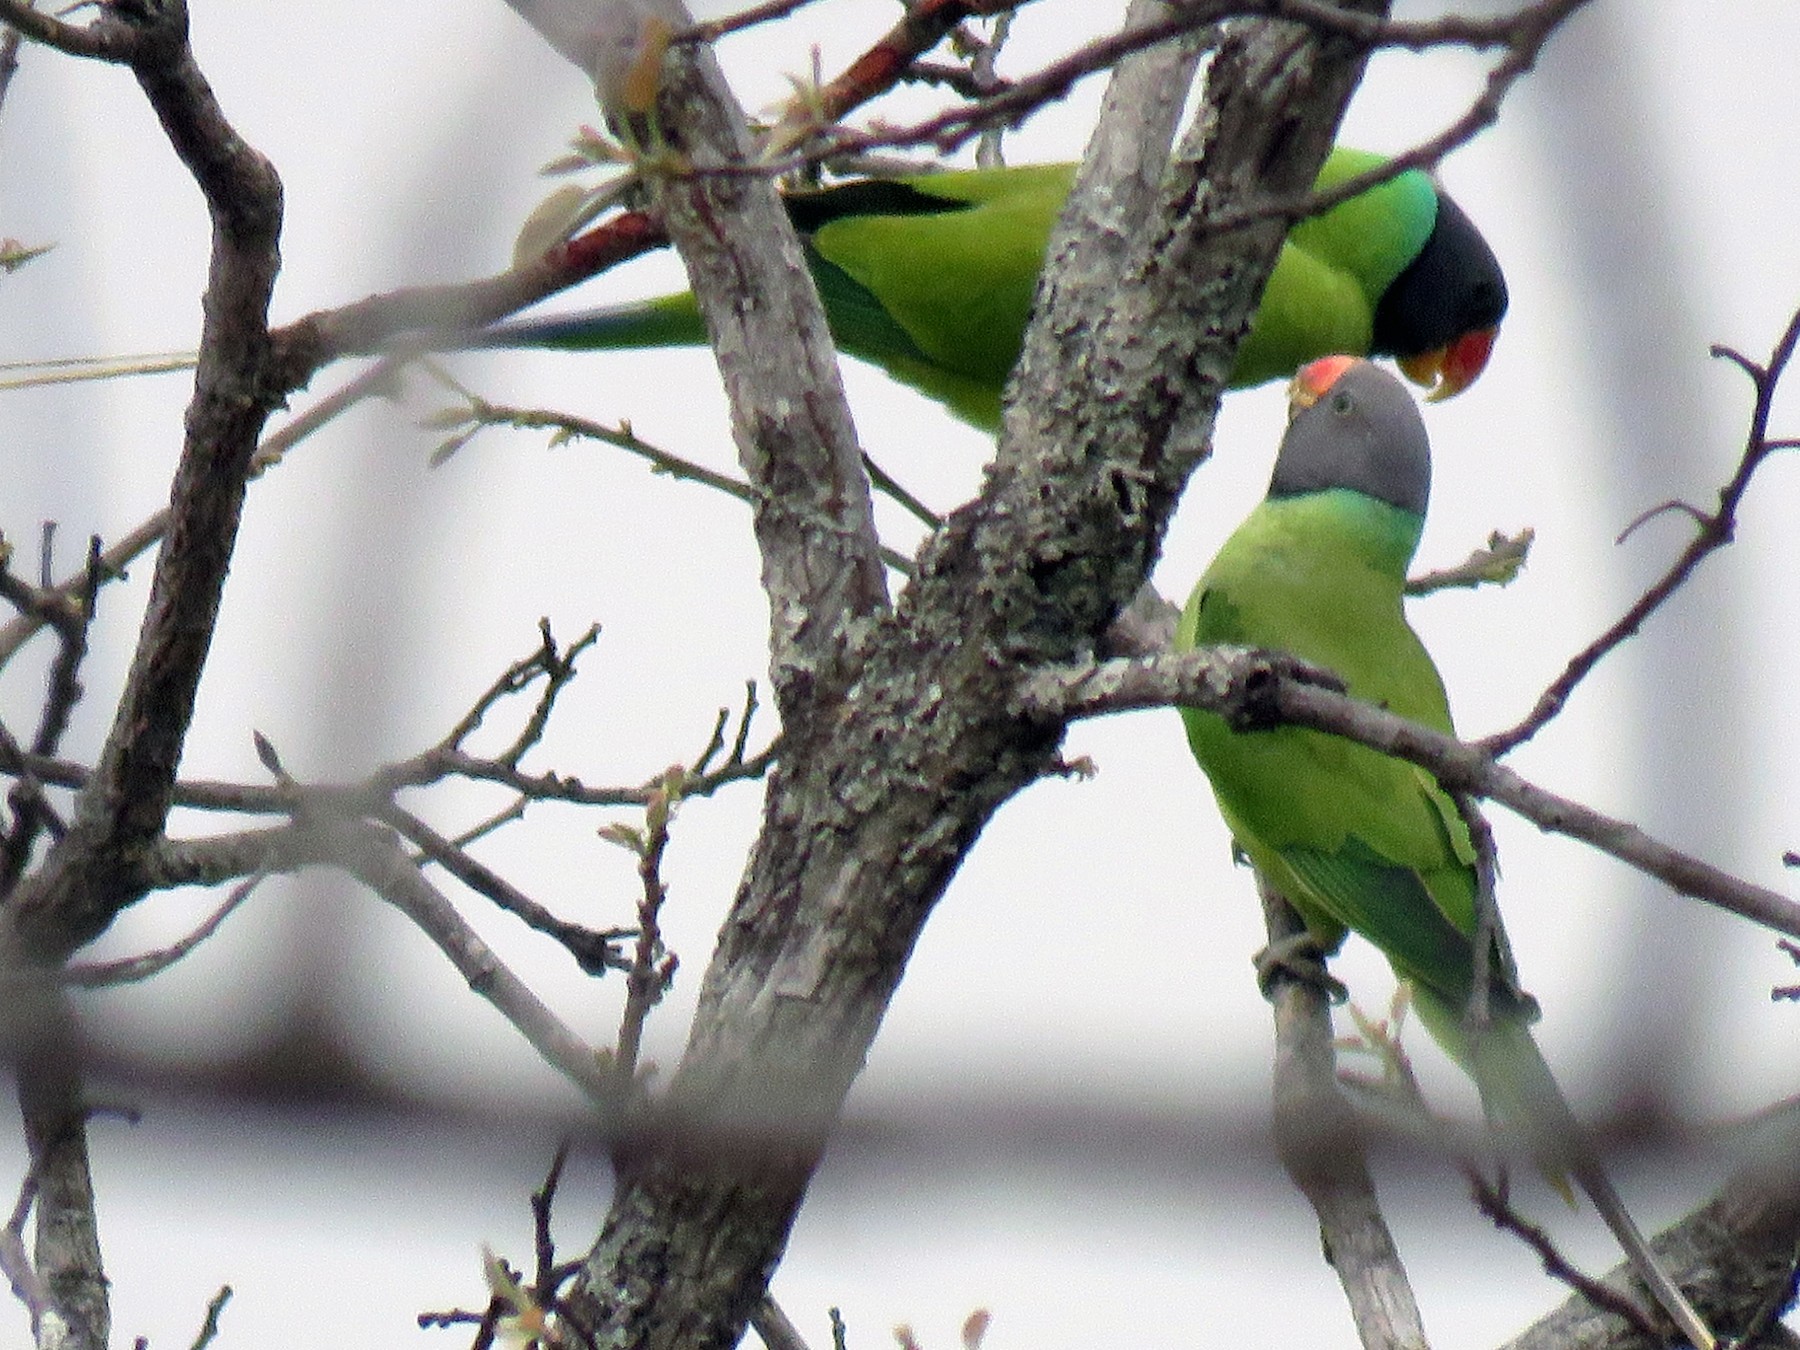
0;0;1800;1350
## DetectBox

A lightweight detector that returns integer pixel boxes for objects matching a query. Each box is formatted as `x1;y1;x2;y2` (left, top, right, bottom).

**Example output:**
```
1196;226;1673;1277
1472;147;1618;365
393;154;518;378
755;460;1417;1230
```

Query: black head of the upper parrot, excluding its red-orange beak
1370;193;1507;356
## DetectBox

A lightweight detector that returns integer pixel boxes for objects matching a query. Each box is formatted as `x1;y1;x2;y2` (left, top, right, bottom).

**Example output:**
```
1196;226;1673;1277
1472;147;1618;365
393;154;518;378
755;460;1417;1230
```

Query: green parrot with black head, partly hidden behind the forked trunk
470;148;1507;430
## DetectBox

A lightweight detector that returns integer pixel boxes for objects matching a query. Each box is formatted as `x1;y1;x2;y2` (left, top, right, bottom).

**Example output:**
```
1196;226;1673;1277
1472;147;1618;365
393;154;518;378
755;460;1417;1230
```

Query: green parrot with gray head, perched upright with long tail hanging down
1175;356;1715;1350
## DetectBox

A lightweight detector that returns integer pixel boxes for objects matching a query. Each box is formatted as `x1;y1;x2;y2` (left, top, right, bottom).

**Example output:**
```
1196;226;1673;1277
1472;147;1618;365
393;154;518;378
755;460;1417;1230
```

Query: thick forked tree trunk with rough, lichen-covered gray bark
561;5;1389;1348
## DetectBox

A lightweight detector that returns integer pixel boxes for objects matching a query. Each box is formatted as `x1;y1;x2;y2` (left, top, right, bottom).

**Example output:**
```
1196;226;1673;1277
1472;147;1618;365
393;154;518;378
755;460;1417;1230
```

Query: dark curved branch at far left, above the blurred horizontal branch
0;4;281;963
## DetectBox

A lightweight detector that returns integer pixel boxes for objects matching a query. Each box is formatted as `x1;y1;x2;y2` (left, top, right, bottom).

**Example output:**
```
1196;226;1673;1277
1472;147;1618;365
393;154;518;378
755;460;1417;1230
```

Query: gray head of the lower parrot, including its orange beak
1269;356;1431;515
